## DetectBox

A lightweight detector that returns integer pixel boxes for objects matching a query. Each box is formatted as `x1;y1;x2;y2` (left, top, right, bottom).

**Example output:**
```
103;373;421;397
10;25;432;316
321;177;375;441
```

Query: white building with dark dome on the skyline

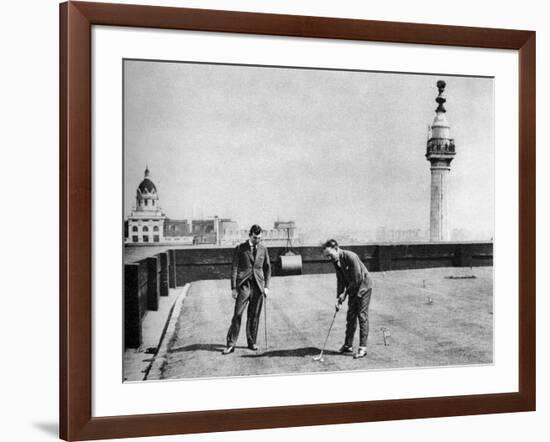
126;167;166;243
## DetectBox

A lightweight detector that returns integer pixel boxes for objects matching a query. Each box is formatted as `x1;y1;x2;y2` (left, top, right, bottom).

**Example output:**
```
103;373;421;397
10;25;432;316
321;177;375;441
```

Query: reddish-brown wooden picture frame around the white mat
60;2;536;440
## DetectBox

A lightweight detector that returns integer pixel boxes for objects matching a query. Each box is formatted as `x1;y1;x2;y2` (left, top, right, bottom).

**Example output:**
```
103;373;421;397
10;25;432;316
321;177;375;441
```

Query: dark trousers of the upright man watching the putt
227;278;264;347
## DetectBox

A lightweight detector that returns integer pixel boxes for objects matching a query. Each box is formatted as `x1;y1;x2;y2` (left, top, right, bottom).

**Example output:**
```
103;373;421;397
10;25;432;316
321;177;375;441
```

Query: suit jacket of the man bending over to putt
333;250;372;297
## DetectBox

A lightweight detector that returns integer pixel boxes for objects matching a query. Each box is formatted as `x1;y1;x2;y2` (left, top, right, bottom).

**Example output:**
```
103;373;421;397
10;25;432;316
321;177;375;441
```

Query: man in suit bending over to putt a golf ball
323;239;373;359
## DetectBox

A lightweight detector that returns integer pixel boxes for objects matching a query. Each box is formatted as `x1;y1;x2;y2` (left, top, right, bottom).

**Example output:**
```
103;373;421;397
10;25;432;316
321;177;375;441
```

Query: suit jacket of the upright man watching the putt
231;241;271;291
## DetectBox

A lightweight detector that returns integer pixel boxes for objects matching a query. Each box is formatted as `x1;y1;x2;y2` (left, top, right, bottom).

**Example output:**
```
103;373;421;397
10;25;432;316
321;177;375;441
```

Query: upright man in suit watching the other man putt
222;224;271;355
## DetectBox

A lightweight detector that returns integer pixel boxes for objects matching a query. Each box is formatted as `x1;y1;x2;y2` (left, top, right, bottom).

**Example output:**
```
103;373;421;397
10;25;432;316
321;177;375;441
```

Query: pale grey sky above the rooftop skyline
124;60;494;239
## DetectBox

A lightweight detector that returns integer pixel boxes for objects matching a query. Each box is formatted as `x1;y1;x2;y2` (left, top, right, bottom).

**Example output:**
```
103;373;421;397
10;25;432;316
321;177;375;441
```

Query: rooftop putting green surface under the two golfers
156;267;493;379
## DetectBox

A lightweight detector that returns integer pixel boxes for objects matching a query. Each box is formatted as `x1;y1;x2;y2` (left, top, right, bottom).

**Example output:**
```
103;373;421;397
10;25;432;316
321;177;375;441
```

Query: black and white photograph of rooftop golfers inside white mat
121;59;495;382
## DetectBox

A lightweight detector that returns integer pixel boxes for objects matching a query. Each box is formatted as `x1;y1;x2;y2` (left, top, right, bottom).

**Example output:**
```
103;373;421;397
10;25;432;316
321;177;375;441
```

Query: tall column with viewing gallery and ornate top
426;80;456;241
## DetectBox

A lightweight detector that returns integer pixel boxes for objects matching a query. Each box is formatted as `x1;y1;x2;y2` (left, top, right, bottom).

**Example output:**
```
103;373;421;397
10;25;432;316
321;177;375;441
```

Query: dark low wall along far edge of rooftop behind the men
173;242;493;286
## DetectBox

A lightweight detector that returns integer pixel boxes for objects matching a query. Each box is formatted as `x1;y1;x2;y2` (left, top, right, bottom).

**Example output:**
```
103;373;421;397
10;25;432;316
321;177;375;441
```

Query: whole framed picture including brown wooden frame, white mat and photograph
60;2;535;440
